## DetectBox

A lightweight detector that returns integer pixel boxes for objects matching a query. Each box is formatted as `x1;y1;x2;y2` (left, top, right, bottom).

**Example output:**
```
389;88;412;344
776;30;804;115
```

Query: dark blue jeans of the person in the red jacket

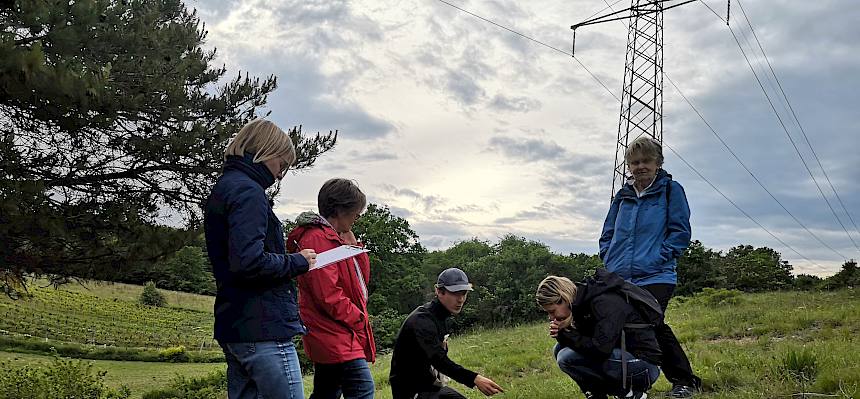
310;359;375;399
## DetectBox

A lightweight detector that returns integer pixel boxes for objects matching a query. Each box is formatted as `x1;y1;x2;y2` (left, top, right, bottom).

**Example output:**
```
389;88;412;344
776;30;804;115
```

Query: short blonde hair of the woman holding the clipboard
224;119;296;166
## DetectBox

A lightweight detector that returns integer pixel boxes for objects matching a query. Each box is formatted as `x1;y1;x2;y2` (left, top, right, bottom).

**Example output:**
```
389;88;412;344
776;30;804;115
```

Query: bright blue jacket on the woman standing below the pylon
600;169;691;286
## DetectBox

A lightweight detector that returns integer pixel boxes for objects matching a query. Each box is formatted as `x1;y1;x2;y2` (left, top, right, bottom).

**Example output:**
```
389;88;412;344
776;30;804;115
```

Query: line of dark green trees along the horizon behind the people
90;204;860;348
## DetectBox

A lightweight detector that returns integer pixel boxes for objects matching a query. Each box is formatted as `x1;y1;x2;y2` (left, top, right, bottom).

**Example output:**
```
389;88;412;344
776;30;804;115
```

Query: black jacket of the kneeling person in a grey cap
389;299;478;399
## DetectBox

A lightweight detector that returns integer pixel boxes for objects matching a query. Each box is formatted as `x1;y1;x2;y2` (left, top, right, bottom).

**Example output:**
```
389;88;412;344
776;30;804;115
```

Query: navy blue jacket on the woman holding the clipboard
204;154;308;342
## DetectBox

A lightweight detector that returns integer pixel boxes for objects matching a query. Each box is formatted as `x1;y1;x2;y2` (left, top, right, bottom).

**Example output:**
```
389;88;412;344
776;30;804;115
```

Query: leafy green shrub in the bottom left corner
0;357;131;399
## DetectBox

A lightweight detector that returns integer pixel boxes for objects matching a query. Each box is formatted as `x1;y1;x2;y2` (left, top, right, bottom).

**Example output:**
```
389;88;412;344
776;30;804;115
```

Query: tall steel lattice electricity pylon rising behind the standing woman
570;0;695;196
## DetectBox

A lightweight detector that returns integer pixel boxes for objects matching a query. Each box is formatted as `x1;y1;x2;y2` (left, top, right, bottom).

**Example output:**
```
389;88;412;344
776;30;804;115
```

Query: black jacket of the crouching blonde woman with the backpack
557;270;661;365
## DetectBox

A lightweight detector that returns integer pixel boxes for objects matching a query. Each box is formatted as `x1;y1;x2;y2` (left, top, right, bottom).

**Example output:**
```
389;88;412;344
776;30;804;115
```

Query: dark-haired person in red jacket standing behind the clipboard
287;179;376;399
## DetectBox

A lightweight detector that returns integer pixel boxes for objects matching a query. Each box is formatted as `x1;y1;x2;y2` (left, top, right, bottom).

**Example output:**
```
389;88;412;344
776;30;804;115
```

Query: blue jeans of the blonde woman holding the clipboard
221;341;305;399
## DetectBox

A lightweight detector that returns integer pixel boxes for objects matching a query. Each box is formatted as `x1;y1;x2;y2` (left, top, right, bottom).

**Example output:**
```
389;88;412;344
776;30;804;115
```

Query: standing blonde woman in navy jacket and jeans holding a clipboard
204;119;316;399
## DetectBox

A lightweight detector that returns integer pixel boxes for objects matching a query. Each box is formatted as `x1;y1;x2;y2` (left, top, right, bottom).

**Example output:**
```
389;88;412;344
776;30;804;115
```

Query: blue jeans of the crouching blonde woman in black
553;344;660;395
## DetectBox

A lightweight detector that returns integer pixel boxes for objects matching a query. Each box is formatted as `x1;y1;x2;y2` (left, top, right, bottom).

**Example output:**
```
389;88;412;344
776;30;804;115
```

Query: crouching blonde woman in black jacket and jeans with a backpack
536;270;662;399
